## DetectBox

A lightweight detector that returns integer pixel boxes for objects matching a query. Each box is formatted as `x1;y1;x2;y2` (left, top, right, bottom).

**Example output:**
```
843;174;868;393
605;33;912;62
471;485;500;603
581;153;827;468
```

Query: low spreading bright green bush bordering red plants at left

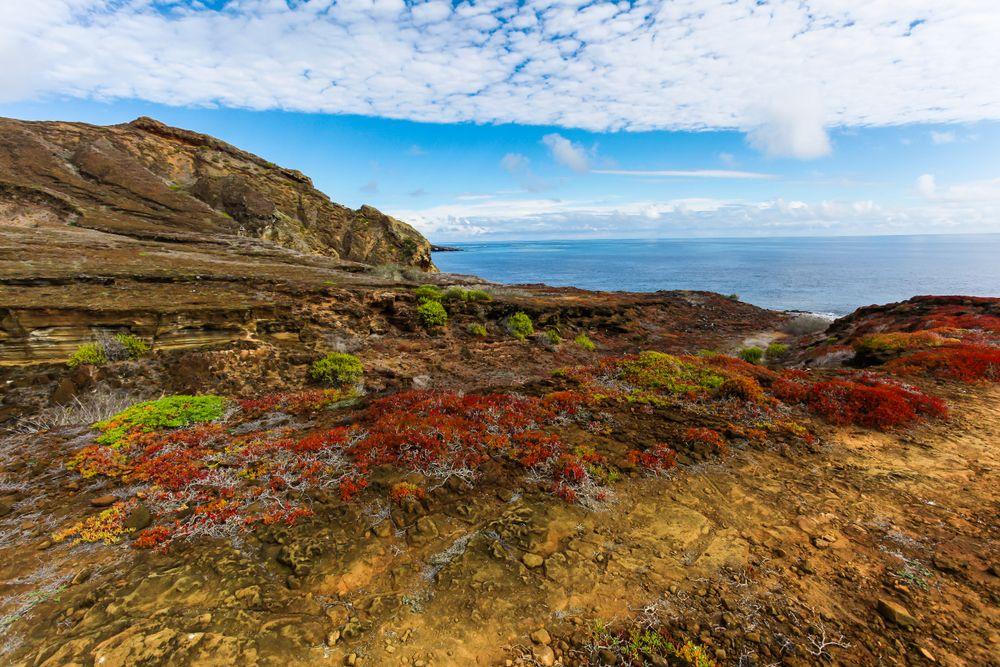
94;395;226;447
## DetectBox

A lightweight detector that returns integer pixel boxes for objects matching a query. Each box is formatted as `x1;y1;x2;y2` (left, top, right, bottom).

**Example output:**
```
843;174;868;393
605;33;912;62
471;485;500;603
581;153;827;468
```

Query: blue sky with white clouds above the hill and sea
0;0;1000;243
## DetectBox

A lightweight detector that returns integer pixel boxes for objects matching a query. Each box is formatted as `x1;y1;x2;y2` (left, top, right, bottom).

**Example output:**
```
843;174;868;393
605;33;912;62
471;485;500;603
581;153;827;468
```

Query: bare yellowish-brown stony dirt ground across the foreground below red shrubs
0;360;1000;665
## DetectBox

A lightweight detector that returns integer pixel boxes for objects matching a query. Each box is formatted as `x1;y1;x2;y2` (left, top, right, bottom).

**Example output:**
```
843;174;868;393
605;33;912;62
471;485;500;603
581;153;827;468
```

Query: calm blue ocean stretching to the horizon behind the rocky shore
434;234;1000;316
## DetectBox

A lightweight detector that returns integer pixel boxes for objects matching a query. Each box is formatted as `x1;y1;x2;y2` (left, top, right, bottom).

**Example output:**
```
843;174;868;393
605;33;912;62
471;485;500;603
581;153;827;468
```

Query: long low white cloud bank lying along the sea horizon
392;183;1000;241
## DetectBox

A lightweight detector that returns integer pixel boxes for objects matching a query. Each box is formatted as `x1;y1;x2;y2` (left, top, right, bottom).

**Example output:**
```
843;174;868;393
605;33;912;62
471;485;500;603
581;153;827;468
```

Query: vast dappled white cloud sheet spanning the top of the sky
0;0;1000;137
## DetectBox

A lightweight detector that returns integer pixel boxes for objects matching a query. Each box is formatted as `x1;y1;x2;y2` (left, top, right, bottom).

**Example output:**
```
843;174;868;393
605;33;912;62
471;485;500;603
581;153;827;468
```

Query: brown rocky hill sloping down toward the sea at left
0;118;434;270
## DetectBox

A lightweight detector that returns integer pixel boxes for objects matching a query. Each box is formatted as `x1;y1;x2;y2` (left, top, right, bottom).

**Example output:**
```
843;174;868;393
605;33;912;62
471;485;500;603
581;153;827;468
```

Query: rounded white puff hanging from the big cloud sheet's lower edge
747;97;831;160
